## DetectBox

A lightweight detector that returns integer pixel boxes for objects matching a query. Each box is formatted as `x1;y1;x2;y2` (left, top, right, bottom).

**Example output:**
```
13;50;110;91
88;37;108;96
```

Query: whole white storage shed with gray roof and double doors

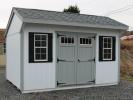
6;8;128;93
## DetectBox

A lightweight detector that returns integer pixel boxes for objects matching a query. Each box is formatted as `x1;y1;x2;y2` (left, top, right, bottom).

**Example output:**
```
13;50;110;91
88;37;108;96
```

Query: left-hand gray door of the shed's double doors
57;34;76;85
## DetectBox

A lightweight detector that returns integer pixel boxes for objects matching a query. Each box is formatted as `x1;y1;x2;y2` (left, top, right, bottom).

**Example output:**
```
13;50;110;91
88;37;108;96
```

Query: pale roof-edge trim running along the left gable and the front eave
5;8;129;37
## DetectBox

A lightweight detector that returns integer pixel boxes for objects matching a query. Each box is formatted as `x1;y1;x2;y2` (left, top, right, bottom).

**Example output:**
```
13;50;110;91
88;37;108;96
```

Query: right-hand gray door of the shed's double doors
77;35;94;84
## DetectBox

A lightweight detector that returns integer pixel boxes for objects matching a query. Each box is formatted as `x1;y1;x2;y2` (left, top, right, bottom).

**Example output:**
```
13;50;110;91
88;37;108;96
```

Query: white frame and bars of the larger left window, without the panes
34;33;48;61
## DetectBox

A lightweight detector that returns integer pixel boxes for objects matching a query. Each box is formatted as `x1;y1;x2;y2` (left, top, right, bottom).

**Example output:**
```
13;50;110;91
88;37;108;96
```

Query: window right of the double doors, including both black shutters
99;36;116;61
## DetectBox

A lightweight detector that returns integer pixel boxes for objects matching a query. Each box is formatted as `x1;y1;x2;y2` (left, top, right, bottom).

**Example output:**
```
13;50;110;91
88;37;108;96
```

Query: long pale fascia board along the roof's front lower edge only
23;18;128;30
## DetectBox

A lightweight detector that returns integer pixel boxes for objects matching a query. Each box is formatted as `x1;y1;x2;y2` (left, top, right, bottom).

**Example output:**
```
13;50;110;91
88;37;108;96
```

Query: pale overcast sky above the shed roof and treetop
0;0;133;30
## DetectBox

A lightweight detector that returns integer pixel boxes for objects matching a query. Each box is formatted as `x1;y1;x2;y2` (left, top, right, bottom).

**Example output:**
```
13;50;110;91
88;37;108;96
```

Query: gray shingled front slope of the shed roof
15;8;128;27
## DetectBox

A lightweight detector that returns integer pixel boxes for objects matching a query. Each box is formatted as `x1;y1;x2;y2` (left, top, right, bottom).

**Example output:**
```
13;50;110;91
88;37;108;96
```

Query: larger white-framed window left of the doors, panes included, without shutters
34;34;48;61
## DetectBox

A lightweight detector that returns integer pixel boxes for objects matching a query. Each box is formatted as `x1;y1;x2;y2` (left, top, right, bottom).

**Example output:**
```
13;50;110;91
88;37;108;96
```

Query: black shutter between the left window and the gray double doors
48;33;53;62
